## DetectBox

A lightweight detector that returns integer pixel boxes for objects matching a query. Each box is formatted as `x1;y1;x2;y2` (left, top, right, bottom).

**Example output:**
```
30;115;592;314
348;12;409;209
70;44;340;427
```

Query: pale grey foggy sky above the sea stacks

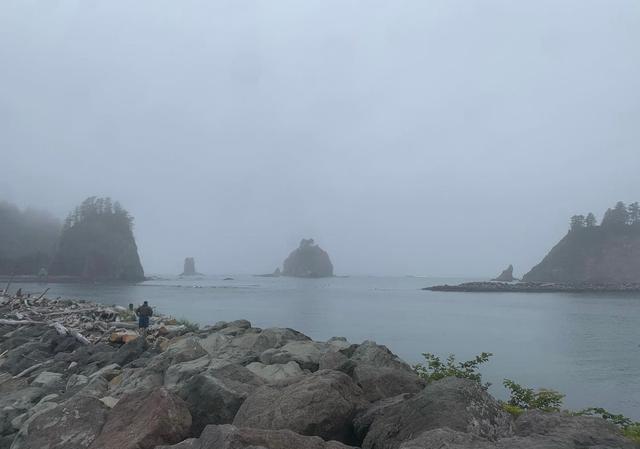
0;0;640;276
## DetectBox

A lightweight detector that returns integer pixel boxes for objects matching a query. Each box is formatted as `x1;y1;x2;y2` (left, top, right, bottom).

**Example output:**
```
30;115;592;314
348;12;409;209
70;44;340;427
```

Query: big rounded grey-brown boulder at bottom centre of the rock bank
233;370;366;444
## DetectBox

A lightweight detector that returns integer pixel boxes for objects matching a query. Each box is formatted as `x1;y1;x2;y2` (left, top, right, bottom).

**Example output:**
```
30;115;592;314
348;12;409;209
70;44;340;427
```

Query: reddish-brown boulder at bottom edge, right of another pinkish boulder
91;388;191;449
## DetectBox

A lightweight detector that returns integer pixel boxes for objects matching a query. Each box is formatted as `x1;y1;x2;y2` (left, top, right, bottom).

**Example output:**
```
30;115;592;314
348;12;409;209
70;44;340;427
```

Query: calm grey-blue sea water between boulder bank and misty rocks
12;276;640;419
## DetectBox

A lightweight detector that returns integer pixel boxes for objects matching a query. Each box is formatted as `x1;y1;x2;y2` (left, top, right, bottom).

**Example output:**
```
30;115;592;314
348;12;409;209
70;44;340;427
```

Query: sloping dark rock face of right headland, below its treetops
523;223;640;284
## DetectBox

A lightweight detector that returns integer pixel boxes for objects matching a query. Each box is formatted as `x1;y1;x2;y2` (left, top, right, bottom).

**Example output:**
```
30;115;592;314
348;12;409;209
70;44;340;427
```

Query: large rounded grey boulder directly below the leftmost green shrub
362;377;512;449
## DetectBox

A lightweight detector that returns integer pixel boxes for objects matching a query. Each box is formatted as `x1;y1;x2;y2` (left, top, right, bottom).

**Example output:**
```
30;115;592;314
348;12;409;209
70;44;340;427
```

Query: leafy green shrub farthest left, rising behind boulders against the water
413;352;493;389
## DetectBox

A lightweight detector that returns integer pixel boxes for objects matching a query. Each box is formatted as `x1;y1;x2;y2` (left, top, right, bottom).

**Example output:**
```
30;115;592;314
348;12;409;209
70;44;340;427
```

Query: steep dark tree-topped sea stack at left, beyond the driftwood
50;197;144;281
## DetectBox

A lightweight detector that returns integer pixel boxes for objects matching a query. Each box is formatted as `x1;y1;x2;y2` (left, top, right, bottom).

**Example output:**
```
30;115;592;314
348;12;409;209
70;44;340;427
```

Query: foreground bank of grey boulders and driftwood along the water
0;298;637;449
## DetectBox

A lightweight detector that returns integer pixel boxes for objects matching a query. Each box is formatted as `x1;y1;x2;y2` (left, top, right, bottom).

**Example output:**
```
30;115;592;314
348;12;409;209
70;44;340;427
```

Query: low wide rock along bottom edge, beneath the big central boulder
156;424;350;449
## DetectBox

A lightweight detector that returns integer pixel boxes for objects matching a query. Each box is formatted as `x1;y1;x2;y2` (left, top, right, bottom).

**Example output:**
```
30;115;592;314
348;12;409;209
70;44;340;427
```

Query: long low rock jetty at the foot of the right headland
422;281;640;293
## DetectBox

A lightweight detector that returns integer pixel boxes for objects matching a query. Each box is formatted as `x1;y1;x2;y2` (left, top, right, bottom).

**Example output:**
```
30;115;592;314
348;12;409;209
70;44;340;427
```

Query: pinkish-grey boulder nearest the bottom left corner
11;395;107;449
